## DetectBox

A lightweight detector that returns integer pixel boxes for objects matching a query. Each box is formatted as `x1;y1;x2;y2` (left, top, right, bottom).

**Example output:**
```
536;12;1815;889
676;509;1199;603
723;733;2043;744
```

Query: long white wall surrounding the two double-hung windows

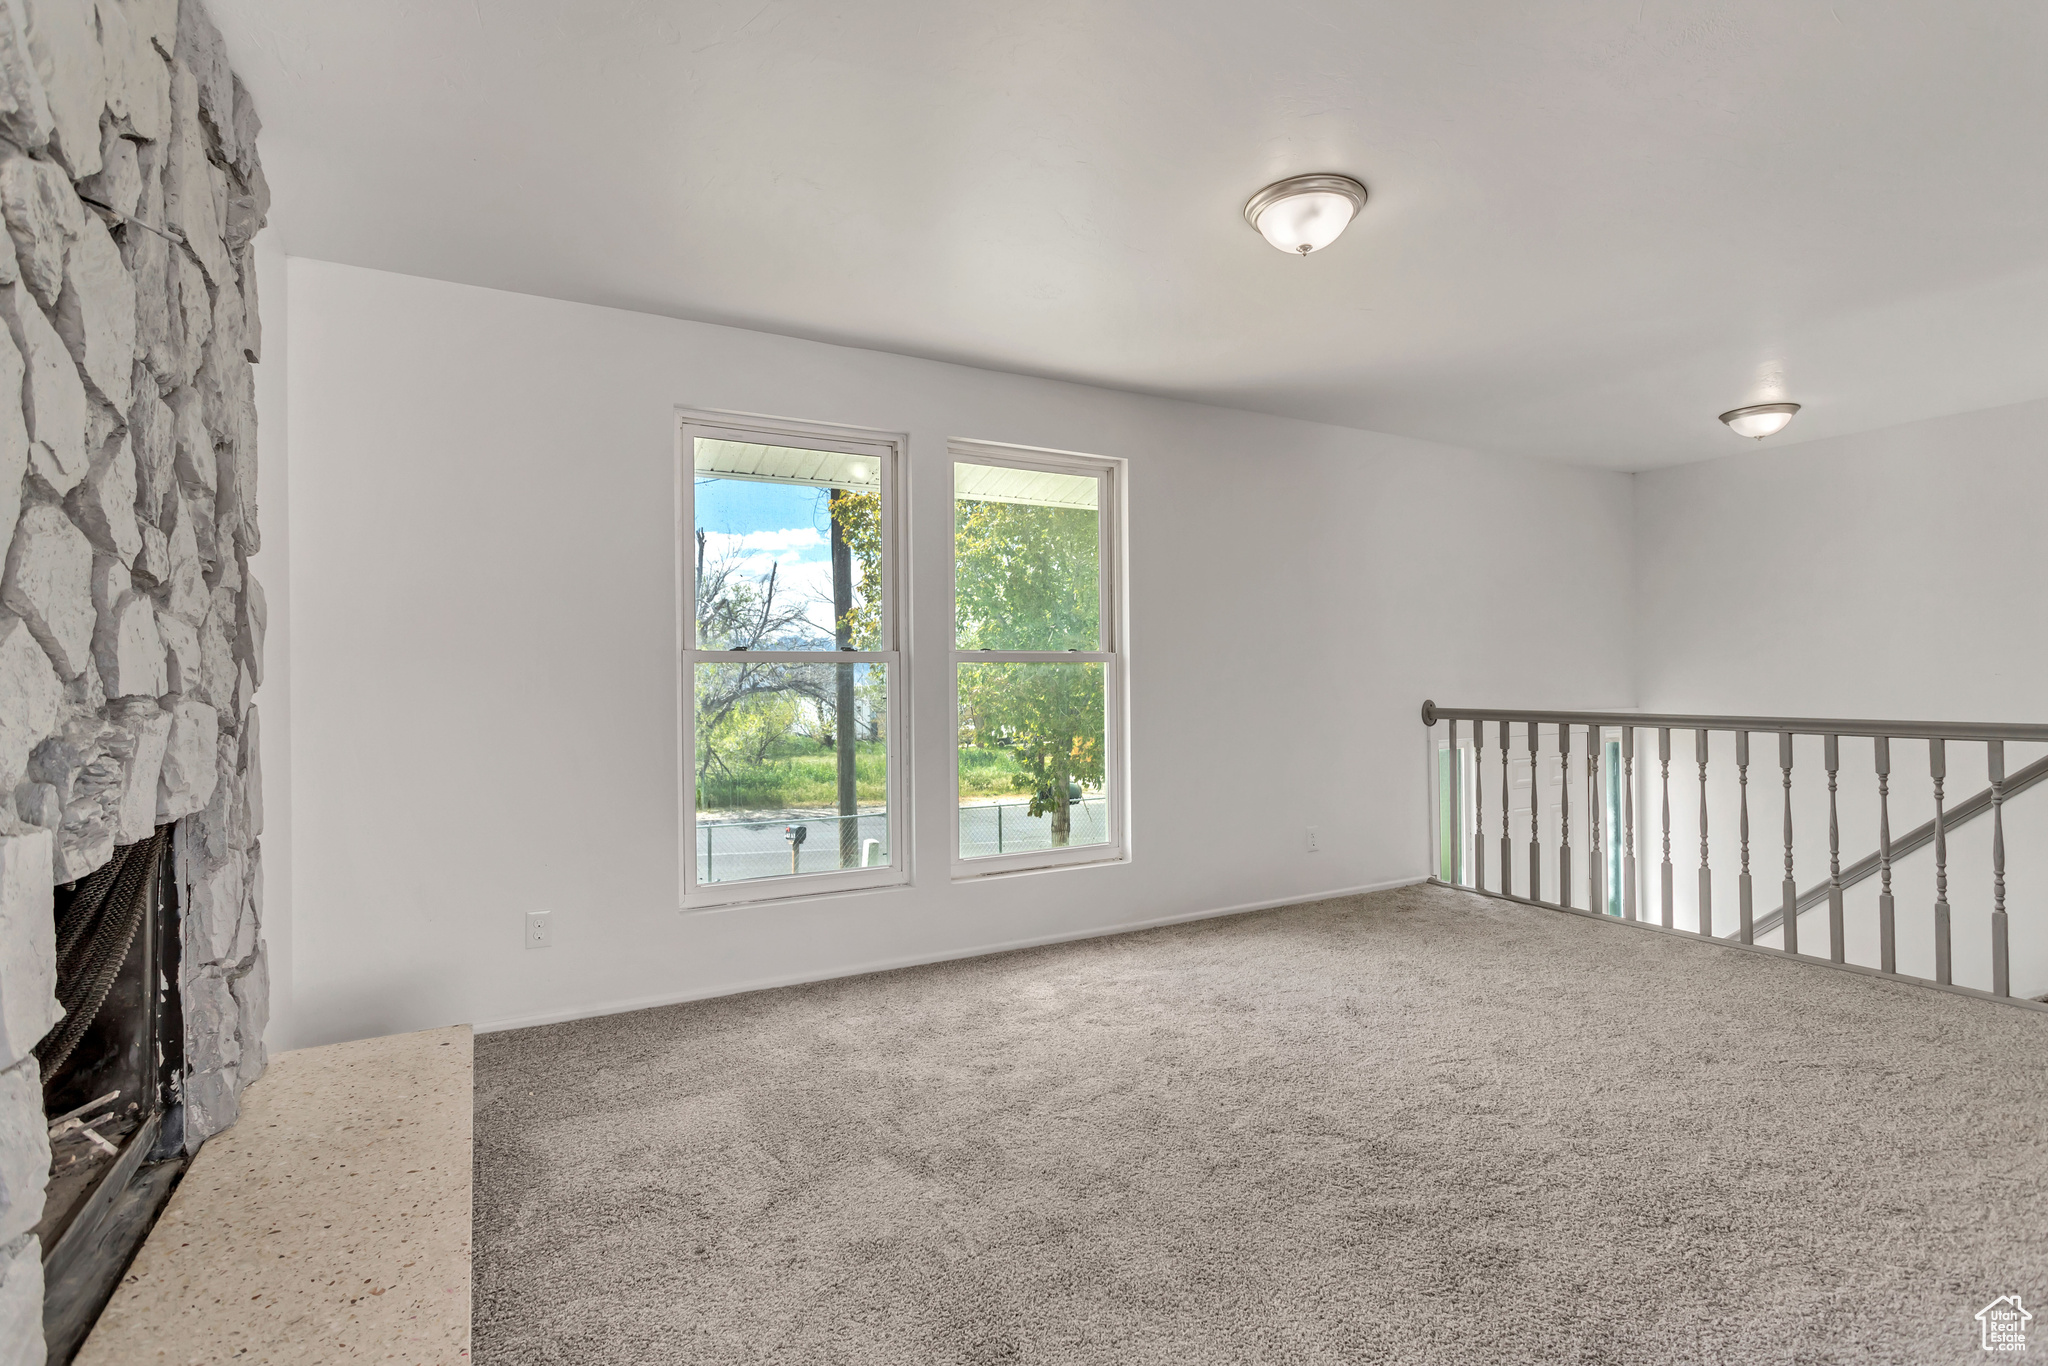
284;260;1630;1042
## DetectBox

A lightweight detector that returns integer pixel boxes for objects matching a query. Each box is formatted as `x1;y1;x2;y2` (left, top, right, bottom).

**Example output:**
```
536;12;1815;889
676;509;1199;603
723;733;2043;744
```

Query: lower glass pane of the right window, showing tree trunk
958;664;1110;858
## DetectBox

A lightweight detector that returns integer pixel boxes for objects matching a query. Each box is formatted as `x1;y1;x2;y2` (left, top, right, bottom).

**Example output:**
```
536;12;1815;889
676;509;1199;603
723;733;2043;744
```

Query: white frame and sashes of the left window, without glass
676;408;911;911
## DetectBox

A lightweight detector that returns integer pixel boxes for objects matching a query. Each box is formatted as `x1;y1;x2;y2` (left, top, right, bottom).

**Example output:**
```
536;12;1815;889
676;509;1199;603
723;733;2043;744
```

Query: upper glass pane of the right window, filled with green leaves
952;463;1102;649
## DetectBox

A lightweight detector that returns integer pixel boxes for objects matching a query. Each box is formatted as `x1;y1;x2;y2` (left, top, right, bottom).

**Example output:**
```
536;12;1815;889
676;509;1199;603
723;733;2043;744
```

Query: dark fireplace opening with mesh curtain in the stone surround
35;825;184;1366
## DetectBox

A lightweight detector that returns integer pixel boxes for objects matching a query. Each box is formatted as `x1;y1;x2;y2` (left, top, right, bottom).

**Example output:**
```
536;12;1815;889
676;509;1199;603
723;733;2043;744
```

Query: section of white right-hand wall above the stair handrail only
1636;401;2048;721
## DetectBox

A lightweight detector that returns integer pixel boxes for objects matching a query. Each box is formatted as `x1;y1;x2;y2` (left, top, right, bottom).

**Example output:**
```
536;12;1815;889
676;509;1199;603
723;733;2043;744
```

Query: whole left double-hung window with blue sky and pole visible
678;414;909;905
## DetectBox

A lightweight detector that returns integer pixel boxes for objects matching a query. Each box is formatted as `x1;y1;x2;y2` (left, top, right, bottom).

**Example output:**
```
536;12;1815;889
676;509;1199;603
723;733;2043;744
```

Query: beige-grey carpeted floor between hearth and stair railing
475;887;2048;1366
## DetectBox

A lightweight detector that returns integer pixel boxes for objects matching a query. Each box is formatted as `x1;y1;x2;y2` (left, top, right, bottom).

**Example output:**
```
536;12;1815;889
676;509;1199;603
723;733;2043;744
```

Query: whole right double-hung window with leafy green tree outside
952;442;1124;877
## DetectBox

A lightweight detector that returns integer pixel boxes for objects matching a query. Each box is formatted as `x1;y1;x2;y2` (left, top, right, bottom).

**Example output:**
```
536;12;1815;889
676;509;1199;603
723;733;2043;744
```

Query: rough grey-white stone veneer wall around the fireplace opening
0;0;270;1366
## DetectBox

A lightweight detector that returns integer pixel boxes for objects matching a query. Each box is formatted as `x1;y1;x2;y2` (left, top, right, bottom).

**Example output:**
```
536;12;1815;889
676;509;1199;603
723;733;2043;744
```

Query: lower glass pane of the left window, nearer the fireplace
696;664;889;883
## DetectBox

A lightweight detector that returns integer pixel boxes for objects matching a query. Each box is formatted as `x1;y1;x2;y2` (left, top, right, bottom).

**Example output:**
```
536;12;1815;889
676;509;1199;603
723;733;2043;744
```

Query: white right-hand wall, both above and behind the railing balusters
1636;401;2048;995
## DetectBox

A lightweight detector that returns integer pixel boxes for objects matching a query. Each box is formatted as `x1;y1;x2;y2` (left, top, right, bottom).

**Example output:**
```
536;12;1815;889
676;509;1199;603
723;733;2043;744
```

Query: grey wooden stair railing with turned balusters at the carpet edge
1421;702;2048;1006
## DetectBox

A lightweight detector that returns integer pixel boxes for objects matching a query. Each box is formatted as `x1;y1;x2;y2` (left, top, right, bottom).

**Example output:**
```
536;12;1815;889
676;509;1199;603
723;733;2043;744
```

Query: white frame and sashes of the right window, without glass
946;438;1130;881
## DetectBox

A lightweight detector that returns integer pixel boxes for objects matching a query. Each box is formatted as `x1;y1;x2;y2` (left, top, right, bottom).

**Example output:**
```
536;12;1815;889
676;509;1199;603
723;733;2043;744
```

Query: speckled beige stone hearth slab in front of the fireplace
78;1026;473;1366
